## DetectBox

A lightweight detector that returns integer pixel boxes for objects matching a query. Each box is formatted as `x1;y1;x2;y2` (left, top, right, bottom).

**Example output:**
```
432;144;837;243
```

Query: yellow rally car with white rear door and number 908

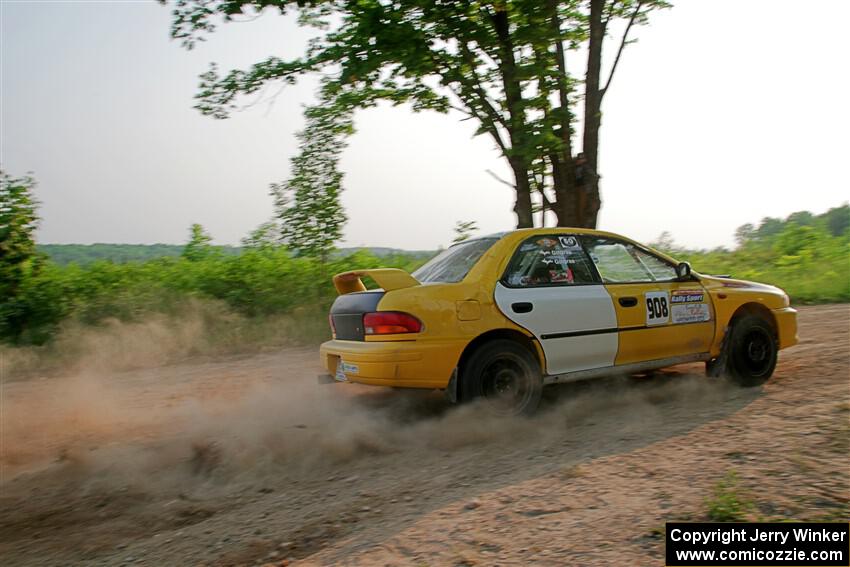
319;228;797;413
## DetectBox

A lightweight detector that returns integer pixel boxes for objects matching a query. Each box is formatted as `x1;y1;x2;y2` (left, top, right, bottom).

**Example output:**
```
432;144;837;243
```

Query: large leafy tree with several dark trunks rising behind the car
163;0;668;231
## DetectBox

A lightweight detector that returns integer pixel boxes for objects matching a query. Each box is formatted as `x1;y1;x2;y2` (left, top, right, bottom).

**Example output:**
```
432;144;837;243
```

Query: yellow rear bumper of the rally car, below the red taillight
319;340;463;388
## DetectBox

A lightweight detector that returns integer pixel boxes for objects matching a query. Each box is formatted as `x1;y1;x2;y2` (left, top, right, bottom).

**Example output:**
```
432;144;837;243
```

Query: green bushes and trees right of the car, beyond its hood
660;205;850;303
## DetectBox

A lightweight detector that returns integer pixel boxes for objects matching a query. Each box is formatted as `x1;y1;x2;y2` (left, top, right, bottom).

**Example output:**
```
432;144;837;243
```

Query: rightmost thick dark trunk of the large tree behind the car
578;0;605;228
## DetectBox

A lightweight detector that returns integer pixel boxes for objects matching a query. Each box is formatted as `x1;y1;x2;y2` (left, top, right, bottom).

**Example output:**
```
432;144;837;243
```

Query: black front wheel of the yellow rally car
719;315;779;388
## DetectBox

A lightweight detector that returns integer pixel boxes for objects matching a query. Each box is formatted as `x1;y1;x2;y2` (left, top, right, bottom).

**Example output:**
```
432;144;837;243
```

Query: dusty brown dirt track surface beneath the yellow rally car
0;305;850;565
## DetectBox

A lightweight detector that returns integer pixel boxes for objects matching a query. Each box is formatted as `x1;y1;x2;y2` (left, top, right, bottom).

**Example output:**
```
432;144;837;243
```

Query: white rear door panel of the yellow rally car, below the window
496;282;618;374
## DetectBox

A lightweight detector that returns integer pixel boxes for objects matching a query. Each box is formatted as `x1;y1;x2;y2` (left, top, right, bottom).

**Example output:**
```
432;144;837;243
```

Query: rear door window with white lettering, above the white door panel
504;235;599;287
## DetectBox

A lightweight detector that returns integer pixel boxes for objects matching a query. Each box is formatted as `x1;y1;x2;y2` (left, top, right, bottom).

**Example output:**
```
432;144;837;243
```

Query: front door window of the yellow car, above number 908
583;236;676;283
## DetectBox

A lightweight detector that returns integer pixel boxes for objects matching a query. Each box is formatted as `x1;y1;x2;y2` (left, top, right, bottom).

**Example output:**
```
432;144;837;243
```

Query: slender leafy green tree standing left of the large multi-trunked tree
272;104;352;262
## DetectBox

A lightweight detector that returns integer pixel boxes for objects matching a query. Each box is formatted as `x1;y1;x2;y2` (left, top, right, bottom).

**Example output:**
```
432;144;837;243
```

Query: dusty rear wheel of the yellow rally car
460;339;543;415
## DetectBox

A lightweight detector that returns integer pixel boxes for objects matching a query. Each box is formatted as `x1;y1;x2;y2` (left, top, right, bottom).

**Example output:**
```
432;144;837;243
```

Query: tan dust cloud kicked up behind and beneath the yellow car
0;310;727;490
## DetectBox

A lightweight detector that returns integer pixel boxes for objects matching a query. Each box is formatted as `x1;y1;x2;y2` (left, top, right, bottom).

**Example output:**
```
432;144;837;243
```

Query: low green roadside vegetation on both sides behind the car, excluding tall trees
0;168;850;345
